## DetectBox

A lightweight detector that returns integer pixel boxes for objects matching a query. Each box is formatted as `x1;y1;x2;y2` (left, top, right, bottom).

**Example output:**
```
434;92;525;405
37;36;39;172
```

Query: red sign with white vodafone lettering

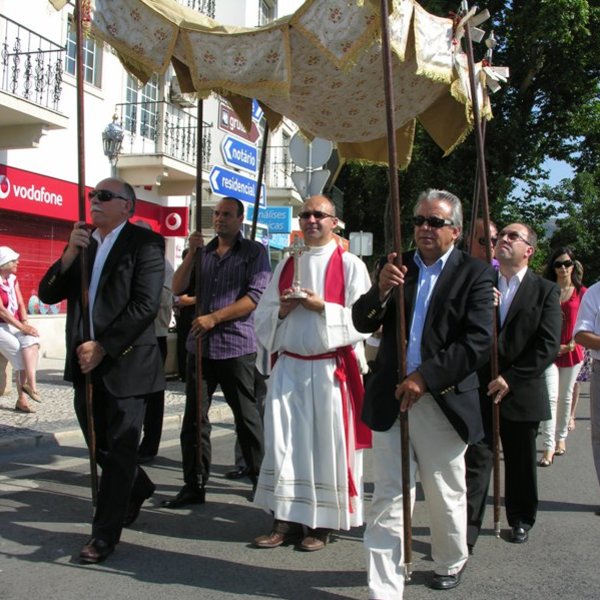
0;165;79;221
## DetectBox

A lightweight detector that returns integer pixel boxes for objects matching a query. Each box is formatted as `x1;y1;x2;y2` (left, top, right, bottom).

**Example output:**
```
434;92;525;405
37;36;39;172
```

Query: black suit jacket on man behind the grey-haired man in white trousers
480;269;562;421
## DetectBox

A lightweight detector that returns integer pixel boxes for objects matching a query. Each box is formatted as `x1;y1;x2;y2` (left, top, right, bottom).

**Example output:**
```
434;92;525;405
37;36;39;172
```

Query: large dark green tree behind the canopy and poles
337;0;600;257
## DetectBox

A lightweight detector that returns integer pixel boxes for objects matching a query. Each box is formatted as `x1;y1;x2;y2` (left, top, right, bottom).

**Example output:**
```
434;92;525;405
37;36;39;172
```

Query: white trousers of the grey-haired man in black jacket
364;394;468;600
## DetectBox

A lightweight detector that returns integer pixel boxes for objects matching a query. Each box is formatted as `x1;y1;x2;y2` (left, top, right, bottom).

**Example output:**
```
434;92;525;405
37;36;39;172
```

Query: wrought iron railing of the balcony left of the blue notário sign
116;100;212;171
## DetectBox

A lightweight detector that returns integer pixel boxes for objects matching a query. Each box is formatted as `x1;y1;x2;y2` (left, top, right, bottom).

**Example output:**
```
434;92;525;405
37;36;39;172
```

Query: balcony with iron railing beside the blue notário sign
116;100;212;195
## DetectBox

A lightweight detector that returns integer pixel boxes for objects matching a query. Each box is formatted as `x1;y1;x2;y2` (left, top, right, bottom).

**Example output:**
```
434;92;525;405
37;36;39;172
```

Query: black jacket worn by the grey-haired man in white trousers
352;249;494;443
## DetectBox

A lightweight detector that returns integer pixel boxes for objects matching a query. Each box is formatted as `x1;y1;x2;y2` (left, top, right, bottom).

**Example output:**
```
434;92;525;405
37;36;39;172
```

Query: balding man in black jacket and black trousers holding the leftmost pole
39;178;164;563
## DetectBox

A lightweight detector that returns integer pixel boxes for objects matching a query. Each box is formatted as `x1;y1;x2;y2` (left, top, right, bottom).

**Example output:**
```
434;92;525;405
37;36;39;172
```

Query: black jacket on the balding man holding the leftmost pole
39;223;165;398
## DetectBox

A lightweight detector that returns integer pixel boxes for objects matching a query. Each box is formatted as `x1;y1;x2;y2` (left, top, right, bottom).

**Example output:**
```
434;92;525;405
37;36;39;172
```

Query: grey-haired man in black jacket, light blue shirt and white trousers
352;190;494;600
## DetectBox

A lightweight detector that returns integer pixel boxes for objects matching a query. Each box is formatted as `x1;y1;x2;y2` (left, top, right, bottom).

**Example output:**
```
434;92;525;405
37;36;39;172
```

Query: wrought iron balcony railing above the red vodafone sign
0;15;65;111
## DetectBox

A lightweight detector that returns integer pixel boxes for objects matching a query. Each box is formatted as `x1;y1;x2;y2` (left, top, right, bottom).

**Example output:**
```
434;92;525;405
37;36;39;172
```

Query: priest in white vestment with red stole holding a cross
254;196;371;551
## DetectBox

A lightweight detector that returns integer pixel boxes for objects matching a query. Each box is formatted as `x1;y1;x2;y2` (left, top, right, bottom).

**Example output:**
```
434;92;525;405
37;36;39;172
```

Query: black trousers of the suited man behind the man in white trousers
465;417;539;545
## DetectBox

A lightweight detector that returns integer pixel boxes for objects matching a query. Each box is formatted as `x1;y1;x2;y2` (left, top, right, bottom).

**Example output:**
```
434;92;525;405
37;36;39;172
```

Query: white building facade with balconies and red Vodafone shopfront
0;0;310;352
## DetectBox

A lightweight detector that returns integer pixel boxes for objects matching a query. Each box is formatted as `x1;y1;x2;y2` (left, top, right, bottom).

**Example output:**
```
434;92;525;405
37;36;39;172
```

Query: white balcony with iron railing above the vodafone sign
0;15;67;148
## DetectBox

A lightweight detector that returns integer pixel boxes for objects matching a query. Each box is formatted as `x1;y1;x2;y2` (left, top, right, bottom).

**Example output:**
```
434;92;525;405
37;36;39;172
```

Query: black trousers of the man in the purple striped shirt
180;353;264;488
